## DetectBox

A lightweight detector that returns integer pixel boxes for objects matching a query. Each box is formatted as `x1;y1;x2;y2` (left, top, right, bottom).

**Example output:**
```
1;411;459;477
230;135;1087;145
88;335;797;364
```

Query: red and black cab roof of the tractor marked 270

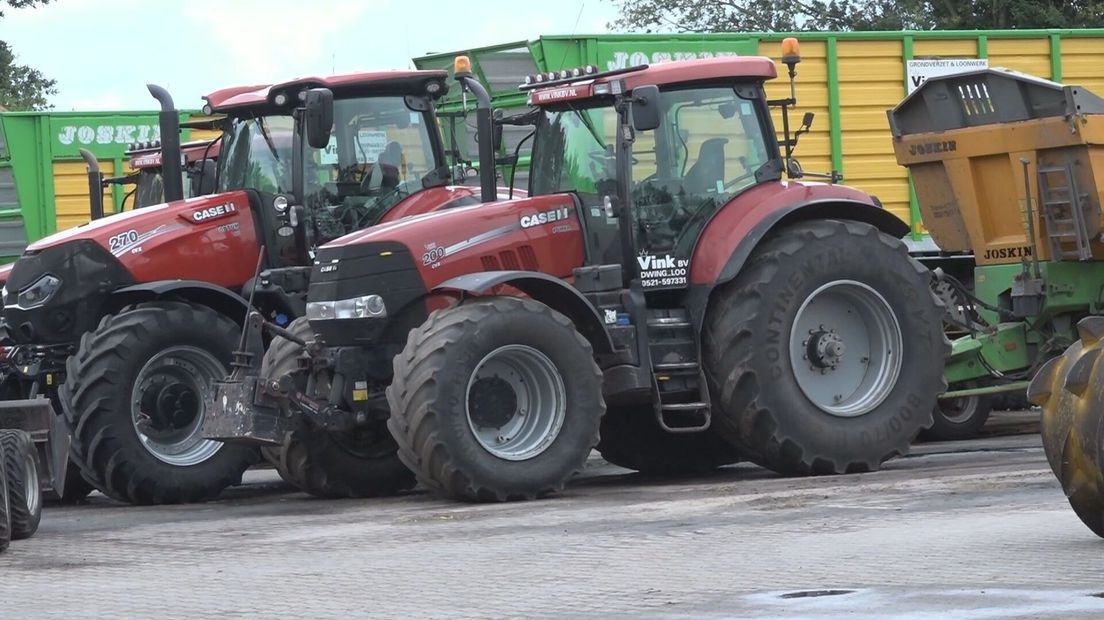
203;71;448;113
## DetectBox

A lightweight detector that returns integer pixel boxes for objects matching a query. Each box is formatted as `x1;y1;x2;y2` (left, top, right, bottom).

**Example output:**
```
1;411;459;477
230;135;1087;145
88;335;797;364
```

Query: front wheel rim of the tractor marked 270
130;346;226;467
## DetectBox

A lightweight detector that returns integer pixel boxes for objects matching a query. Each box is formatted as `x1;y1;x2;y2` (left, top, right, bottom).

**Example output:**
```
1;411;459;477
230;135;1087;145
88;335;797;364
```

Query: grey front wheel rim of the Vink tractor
465;344;567;461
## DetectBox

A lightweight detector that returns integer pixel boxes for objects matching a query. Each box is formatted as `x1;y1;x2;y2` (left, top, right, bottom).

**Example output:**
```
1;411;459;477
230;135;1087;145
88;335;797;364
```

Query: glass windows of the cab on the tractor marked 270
219;96;440;243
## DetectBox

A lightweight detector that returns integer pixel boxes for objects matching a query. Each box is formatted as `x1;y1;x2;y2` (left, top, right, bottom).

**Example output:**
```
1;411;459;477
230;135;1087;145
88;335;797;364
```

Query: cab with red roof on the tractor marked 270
204;72;457;265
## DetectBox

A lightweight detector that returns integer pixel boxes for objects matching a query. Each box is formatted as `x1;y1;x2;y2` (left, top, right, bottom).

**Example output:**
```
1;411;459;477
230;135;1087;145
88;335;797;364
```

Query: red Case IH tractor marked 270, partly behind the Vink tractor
3;71;493;503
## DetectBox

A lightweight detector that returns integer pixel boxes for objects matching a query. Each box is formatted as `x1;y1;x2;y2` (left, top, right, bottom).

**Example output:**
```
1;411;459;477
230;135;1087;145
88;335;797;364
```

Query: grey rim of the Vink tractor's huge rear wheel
789;280;902;418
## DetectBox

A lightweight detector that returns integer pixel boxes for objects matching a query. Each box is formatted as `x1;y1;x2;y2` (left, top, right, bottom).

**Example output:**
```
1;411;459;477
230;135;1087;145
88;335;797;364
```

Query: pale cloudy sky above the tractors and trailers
0;0;616;110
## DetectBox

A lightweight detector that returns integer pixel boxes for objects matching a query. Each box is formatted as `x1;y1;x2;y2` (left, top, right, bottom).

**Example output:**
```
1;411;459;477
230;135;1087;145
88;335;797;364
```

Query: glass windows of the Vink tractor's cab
530;86;771;256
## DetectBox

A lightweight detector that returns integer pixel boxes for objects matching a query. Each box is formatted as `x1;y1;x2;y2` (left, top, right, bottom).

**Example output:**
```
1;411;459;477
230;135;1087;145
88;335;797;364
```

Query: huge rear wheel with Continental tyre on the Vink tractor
702;220;949;475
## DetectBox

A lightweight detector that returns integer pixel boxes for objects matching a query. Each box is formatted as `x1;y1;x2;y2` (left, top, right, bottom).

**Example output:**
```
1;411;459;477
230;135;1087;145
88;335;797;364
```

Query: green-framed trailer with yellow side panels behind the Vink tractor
414;30;1104;255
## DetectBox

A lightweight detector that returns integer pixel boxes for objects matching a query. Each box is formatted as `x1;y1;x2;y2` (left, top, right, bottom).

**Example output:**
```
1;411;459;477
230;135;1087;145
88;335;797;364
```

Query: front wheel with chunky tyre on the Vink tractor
388;297;605;502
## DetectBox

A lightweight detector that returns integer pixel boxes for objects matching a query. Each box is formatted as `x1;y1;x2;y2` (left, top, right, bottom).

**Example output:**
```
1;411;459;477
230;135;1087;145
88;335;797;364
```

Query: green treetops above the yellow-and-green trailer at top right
609;0;1104;32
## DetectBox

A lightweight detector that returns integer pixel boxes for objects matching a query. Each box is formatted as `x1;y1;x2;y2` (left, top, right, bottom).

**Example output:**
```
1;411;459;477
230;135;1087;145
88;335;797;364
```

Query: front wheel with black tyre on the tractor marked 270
60;301;258;504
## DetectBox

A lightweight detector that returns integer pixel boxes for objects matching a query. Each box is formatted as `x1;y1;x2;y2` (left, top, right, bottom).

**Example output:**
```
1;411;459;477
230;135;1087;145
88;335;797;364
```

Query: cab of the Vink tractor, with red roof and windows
526;58;782;271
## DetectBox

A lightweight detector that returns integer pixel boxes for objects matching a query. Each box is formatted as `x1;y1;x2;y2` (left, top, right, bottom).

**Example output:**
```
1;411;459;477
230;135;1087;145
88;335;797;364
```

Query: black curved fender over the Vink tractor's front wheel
432;271;614;355
